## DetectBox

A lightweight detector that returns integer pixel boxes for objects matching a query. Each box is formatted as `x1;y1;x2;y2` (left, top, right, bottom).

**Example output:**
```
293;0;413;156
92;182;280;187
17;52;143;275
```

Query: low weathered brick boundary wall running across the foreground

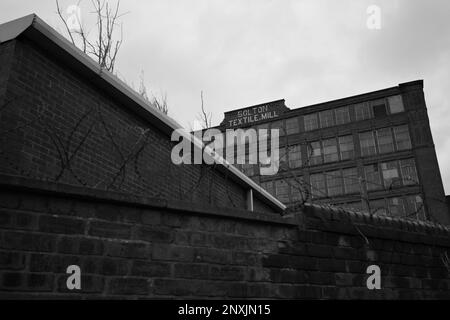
0;176;450;299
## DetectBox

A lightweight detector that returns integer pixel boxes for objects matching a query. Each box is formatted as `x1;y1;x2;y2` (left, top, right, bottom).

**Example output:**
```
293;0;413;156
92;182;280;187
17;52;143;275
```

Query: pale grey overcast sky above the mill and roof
0;0;450;193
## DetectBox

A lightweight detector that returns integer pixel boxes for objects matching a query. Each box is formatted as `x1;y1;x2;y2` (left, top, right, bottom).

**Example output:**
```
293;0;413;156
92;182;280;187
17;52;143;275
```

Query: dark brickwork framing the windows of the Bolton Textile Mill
213;80;450;225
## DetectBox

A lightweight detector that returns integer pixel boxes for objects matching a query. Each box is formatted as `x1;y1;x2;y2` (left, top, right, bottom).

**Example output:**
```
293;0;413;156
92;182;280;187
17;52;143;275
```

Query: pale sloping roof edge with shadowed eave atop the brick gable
0;14;286;212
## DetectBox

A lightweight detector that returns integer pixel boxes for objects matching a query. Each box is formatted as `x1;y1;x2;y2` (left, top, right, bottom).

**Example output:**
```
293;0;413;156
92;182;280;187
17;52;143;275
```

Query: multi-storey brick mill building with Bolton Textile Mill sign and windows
217;80;450;224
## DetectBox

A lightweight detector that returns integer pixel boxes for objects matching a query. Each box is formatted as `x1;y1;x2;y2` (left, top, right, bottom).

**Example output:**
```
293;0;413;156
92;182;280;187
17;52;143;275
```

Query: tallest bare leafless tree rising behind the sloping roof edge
56;0;126;72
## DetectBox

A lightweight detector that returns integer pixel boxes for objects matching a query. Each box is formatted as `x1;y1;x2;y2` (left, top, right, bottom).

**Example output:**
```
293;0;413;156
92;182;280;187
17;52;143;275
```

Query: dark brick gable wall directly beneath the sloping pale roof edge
0;39;273;211
